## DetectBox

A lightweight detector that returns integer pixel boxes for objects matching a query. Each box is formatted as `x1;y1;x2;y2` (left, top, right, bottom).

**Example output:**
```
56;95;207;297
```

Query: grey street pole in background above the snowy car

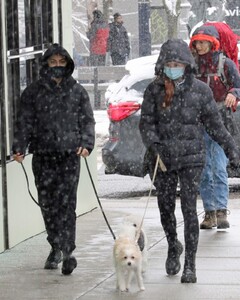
138;0;151;57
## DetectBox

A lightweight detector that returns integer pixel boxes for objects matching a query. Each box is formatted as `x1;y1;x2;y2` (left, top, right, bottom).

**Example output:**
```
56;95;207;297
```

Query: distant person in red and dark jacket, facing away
87;10;109;66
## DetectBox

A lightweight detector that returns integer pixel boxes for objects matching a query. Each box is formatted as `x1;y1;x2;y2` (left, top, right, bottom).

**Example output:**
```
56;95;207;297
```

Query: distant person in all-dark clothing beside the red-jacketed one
107;13;130;65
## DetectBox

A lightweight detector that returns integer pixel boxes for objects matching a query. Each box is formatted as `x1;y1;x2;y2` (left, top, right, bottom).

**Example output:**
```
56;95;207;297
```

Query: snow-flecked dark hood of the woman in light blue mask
155;39;195;75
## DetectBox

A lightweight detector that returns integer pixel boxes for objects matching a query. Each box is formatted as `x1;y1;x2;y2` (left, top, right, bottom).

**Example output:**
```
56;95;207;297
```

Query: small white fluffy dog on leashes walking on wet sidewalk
113;216;147;292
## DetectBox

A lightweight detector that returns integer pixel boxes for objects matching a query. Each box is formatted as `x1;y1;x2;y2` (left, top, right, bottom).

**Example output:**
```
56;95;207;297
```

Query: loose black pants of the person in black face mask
32;153;80;253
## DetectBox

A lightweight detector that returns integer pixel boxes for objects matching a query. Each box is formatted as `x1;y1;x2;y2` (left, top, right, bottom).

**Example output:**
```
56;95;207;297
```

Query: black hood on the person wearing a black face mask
40;43;75;78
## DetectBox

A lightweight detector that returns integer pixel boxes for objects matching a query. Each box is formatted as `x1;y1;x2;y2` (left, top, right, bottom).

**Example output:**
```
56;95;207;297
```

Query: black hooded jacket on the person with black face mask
12;44;95;154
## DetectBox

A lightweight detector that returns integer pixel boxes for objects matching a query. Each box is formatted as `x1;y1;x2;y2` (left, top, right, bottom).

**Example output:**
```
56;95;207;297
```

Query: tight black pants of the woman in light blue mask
154;167;202;253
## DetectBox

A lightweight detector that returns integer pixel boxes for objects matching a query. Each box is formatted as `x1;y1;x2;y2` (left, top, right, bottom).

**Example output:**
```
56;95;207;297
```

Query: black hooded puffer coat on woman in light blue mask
140;40;239;171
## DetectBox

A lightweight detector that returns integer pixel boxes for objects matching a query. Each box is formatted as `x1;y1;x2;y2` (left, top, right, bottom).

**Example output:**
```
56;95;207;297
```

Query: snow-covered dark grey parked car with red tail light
102;55;240;177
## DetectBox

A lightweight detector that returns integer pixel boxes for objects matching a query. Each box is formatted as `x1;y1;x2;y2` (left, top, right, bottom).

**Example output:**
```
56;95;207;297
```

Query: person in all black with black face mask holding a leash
12;44;95;275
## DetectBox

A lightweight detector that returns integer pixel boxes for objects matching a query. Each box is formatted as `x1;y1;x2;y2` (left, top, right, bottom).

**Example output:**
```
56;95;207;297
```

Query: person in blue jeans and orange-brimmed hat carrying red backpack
190;25;240;229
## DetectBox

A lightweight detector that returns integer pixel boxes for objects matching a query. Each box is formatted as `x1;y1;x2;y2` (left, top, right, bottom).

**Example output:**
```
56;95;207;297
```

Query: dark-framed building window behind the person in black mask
3;0;56;159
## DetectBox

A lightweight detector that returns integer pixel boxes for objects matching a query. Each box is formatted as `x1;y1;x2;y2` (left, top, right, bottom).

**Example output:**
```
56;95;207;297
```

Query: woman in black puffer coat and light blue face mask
140;39;240;283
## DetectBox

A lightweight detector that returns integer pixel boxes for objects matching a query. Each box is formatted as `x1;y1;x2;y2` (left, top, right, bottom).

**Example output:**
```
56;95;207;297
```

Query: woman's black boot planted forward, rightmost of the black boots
181;253;197;283
